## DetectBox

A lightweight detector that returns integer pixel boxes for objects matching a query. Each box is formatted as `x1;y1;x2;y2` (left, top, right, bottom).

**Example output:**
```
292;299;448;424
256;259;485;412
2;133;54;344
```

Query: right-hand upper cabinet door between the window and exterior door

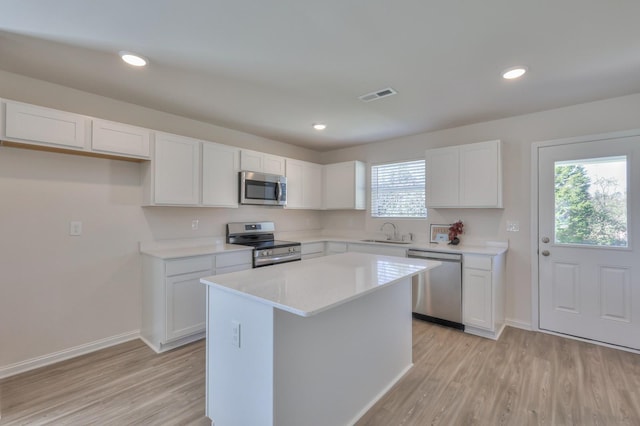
460;141;502;207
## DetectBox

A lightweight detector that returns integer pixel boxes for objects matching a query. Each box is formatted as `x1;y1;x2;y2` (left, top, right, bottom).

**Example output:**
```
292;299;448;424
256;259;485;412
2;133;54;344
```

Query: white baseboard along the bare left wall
0;330;140;379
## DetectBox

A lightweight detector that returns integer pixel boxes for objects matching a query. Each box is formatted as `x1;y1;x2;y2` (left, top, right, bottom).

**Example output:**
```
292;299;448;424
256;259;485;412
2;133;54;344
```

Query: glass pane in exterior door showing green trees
555;156;628;247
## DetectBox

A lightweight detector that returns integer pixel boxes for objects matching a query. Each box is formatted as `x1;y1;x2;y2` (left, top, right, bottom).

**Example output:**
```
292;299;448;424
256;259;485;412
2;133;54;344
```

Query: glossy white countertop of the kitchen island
200;253;440;317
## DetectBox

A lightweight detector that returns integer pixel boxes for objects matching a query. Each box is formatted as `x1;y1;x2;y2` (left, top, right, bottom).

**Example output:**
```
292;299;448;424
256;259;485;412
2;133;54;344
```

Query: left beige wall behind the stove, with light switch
0;72;321;376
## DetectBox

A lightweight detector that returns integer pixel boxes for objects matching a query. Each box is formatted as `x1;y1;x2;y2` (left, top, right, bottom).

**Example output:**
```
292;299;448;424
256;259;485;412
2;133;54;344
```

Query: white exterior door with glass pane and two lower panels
538;136;640;349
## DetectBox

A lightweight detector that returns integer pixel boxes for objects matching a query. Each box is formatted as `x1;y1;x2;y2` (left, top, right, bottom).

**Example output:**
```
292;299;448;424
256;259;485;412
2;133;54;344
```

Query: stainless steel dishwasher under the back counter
407;249;464;330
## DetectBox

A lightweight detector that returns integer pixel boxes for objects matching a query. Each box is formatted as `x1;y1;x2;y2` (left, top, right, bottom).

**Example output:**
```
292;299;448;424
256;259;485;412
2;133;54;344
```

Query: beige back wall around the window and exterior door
321;94;640;326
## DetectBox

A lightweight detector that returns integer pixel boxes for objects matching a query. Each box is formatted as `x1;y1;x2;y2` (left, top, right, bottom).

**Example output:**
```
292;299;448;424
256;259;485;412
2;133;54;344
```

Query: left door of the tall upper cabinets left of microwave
153;133;201;205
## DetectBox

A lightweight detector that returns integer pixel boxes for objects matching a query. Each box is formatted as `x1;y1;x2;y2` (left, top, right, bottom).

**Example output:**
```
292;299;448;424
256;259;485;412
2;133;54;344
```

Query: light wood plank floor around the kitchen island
0;321;640;426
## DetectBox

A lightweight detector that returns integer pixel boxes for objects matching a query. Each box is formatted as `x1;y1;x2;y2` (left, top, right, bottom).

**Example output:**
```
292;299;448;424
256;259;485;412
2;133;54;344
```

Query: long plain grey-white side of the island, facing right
274;278;412;426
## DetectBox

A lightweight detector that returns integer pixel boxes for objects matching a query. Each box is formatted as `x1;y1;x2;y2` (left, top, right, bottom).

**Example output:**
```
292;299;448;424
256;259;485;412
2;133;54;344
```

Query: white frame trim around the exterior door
531;129;640;332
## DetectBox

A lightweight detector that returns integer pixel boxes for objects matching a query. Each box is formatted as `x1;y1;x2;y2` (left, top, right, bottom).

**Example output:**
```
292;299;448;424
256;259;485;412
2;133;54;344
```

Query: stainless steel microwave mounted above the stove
239;171;287;206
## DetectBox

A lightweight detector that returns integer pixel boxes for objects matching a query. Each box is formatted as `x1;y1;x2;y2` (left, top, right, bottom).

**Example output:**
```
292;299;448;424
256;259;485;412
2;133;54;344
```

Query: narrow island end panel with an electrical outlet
206;286;274;426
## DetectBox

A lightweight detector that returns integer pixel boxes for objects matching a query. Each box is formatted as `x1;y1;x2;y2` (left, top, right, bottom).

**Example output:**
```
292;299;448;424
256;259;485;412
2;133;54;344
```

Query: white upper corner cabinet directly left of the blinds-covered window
323;161;366;210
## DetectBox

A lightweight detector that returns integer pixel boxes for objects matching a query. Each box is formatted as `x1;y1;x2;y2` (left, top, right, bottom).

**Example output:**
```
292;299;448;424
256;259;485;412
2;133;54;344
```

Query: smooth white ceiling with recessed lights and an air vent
0;0;640;151
